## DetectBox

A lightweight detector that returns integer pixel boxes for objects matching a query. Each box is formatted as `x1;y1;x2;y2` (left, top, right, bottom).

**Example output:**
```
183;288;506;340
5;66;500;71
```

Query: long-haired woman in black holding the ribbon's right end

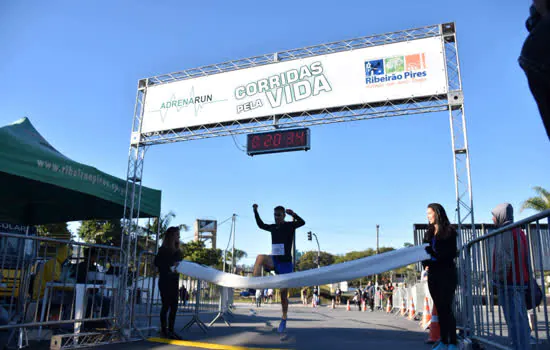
423;203;457;350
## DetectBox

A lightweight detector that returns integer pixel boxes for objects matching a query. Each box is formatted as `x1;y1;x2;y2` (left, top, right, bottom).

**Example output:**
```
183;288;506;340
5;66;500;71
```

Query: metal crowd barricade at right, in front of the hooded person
461;210;550;349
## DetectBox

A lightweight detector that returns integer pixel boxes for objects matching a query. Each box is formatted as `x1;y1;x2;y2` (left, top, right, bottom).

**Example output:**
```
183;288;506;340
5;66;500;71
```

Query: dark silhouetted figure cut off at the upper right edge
519;0;550;139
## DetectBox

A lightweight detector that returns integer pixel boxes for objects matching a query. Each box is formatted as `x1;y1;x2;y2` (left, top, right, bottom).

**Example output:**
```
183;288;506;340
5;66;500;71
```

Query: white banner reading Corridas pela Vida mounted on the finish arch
141;37;447;133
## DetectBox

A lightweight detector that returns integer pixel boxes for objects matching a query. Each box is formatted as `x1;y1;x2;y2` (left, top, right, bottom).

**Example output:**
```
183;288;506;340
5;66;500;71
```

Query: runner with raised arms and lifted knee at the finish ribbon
252;204;306;333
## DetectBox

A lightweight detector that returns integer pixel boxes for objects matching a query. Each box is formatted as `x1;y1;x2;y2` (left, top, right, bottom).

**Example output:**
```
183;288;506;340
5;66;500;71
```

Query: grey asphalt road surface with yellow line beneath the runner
101;305;431;350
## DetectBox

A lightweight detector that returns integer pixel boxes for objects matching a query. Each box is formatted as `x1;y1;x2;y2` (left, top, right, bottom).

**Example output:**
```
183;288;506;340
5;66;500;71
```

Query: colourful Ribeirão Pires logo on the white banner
365;53;428;85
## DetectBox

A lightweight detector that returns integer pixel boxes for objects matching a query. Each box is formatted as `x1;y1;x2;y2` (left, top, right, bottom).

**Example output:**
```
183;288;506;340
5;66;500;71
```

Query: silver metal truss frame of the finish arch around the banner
120;23;474;336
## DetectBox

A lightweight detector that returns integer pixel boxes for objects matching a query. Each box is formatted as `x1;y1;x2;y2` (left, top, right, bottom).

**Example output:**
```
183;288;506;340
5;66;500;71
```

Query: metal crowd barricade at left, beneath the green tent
0;233;120;348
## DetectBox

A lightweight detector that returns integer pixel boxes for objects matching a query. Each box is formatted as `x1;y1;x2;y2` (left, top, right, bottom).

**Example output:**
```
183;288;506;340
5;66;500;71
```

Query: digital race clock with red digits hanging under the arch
246;128;310;156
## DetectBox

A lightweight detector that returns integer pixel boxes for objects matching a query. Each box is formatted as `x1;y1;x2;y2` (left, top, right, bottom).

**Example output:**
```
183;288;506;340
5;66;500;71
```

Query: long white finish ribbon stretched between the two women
176;244;430;289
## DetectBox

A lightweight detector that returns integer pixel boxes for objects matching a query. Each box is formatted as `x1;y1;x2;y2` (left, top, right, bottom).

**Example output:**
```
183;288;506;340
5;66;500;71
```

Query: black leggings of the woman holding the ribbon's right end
428;268;457;344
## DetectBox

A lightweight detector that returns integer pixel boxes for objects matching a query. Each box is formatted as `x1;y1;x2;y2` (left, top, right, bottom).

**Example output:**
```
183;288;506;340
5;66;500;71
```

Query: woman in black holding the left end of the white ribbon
155;226;182;339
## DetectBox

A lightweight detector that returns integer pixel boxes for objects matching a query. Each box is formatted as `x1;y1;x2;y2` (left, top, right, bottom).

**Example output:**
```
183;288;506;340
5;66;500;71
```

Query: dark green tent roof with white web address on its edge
0;118;161;225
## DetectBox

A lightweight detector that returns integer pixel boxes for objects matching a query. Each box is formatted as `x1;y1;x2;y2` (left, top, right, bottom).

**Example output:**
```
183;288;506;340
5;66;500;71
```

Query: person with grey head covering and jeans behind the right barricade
492;203;531;350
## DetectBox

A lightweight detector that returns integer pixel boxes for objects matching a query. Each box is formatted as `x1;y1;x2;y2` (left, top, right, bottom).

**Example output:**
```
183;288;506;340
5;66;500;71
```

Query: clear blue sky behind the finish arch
0;0;550;263
